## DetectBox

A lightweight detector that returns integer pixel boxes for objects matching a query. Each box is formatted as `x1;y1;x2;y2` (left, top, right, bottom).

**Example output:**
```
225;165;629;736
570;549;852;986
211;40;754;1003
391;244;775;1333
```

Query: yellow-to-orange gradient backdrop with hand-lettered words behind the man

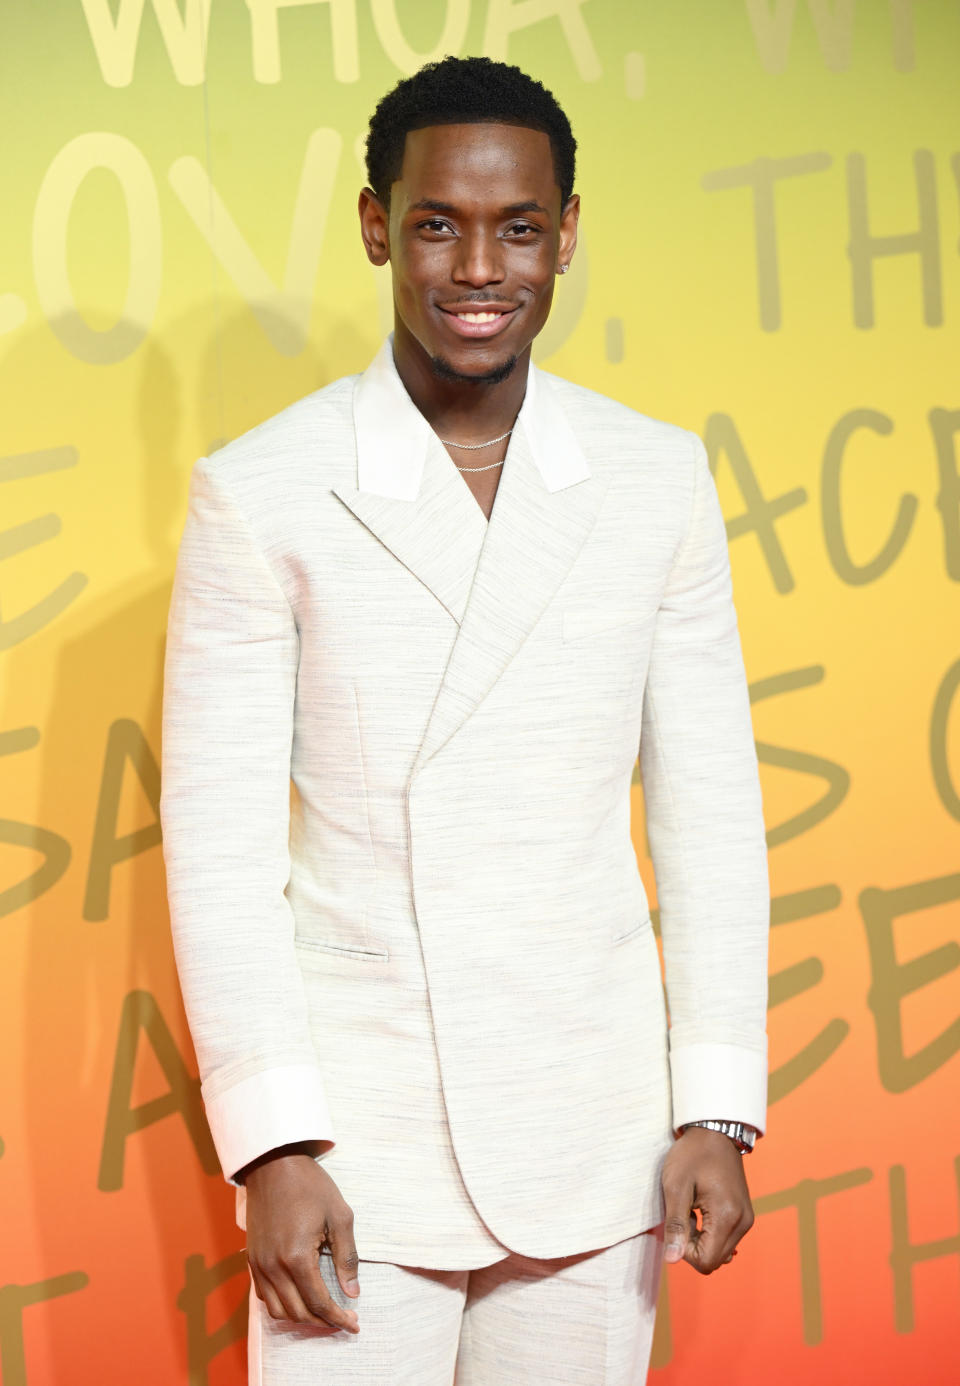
0;0;960;1386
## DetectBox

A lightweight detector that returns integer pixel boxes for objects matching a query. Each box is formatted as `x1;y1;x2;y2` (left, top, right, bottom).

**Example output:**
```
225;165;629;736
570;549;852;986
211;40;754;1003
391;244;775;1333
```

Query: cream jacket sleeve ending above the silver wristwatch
640;432;770;1131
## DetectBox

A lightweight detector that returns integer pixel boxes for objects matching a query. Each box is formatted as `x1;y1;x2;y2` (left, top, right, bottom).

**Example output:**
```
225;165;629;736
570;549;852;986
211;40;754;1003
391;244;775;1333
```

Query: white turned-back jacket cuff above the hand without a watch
204;1063;335;1186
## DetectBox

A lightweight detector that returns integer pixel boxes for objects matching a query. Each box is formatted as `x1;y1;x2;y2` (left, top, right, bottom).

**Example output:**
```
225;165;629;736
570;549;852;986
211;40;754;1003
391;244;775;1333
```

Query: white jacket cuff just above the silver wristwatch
670;1037;766;1135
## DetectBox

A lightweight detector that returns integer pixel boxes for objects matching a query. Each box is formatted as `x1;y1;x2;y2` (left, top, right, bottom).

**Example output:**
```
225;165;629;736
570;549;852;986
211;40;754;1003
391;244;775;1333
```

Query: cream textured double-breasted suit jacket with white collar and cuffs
161;340;769;1270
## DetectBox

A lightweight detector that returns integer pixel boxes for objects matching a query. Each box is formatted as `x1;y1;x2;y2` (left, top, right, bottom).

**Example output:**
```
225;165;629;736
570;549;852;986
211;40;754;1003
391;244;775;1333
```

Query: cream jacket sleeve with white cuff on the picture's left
161;459;332;1184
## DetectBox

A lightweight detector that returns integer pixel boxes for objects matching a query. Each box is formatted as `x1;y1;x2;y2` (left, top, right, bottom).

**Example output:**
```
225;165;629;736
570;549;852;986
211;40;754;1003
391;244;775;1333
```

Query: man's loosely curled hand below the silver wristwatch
661;1127;754;1275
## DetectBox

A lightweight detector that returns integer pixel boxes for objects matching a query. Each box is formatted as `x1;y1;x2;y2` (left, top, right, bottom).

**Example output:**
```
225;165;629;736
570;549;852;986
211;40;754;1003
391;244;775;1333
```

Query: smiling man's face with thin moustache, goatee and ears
362;125;579;383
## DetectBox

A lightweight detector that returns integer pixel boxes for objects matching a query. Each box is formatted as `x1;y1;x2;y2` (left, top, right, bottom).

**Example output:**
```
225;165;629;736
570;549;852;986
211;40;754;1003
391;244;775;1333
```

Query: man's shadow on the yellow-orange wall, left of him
9;305;377;1386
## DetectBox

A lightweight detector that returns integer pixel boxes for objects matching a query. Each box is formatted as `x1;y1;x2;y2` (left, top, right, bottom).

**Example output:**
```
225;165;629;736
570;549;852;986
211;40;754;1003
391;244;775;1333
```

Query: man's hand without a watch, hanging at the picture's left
238;1146;360;1333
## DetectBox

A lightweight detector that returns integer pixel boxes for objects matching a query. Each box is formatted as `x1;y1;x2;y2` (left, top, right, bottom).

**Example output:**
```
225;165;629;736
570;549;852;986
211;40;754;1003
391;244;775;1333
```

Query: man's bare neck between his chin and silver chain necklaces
393;320;531;442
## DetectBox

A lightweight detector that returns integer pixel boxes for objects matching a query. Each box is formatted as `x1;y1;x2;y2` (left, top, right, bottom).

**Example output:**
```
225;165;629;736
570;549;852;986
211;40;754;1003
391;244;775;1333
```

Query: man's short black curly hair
367;57;576;208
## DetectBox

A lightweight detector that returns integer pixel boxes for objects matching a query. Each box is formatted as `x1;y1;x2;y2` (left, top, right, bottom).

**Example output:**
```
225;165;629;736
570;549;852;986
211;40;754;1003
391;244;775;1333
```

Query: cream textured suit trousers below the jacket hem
248;1228;664;1386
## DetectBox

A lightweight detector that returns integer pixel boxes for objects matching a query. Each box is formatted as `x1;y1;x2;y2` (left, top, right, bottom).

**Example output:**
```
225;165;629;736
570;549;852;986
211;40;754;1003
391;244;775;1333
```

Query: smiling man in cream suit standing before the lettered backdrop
161;58;769;1386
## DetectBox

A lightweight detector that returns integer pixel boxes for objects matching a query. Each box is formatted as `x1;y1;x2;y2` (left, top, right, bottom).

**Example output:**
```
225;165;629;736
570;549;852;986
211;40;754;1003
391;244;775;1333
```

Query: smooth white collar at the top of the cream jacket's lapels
353;333;590;500
